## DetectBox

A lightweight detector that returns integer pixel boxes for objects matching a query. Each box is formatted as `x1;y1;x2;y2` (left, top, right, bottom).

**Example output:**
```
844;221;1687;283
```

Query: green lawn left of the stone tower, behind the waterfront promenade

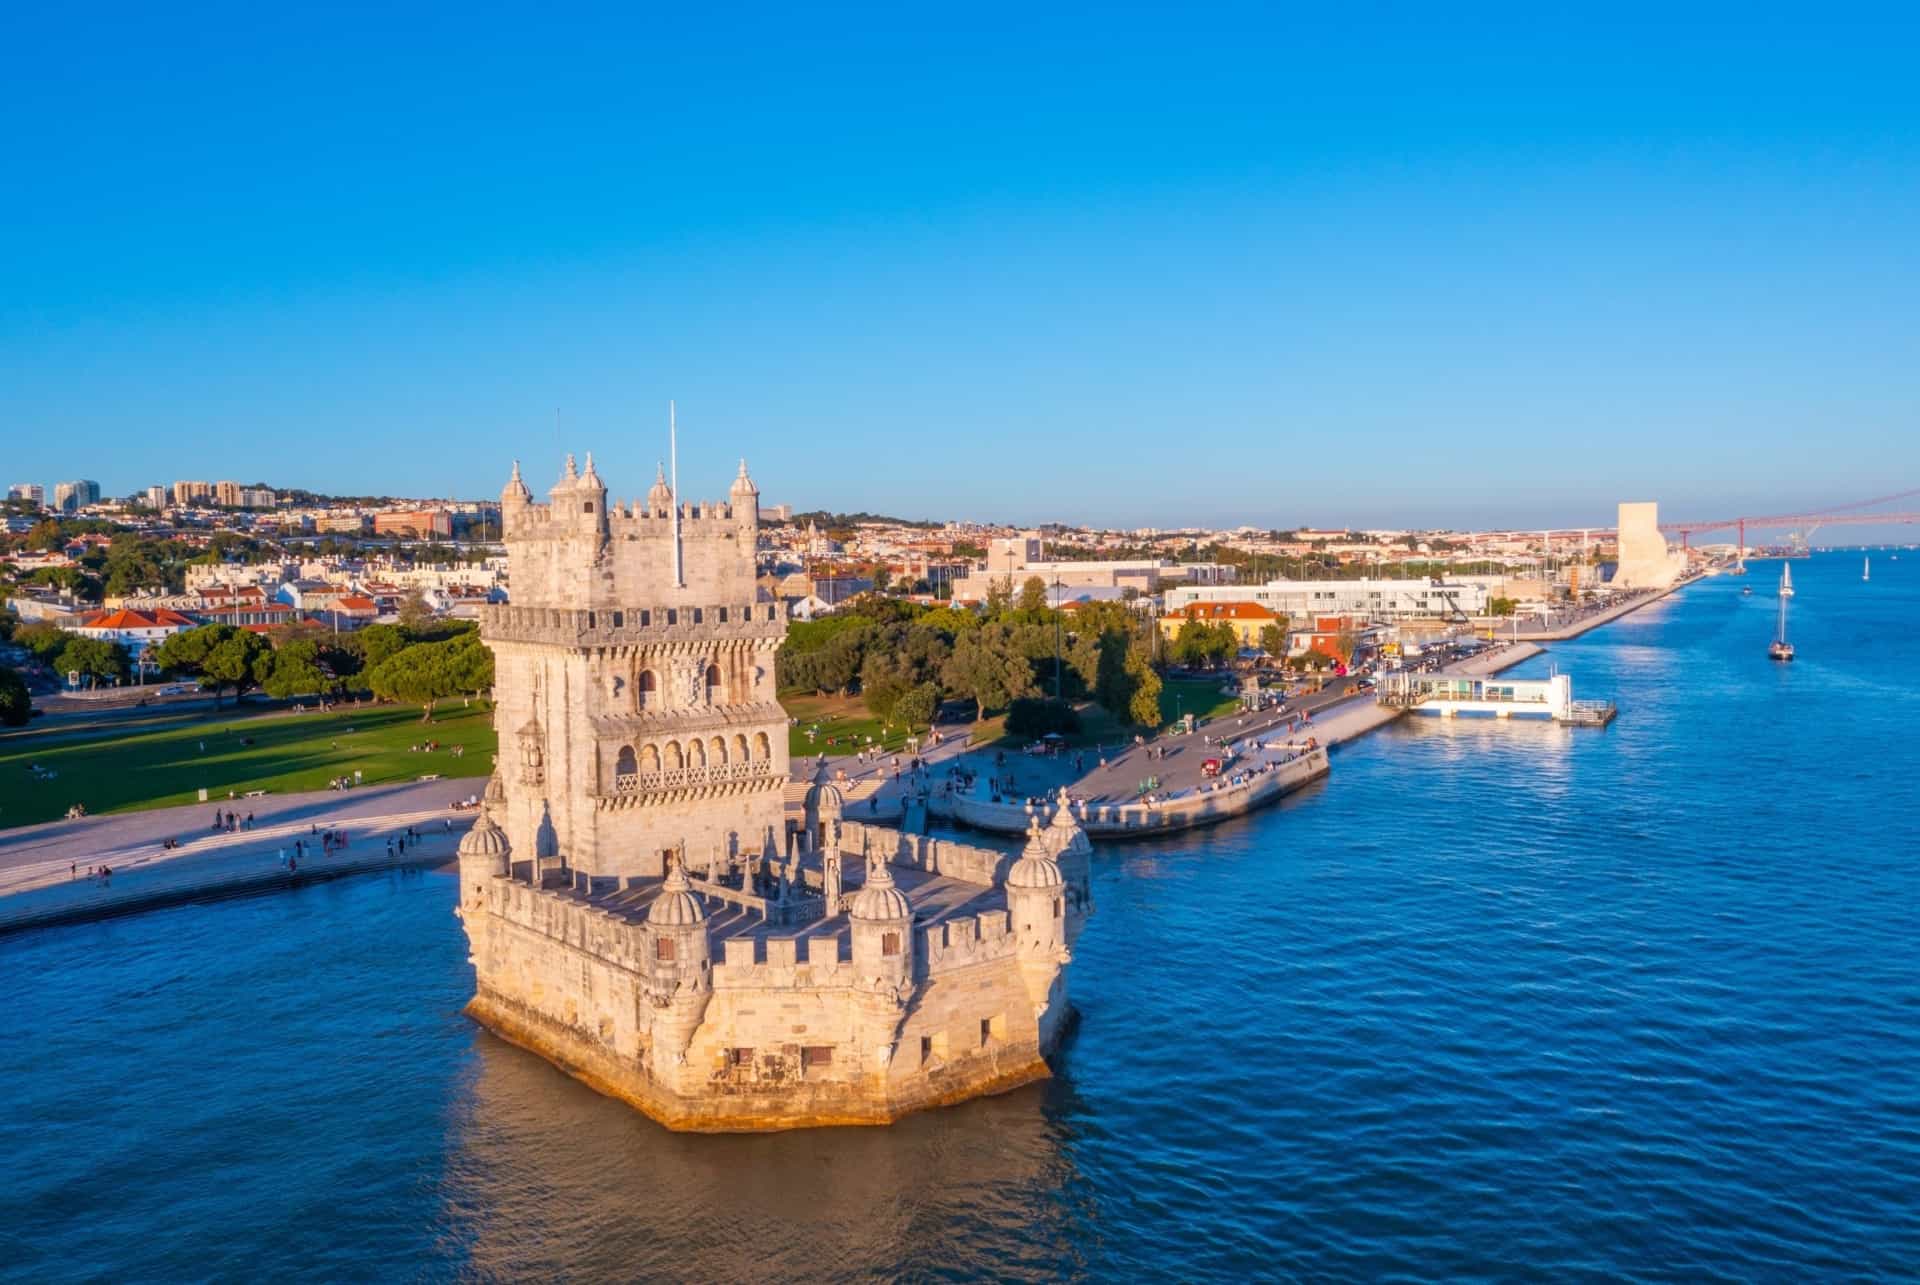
0;705;495;826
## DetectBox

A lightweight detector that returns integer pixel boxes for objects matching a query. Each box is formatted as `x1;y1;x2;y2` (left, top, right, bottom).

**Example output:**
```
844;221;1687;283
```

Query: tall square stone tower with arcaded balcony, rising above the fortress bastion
480;455;787;891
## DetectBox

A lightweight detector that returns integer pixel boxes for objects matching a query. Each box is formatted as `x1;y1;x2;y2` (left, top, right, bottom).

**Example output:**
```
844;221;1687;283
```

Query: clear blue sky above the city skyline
0;4;1920;524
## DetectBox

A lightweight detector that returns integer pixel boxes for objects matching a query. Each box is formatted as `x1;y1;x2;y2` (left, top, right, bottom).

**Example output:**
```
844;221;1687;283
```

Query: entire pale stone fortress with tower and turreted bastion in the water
459;457;1091;1129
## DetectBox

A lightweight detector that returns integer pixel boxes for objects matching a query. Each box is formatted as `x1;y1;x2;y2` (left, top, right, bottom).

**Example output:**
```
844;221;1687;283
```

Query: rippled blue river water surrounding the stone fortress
0;555;1920;1281
